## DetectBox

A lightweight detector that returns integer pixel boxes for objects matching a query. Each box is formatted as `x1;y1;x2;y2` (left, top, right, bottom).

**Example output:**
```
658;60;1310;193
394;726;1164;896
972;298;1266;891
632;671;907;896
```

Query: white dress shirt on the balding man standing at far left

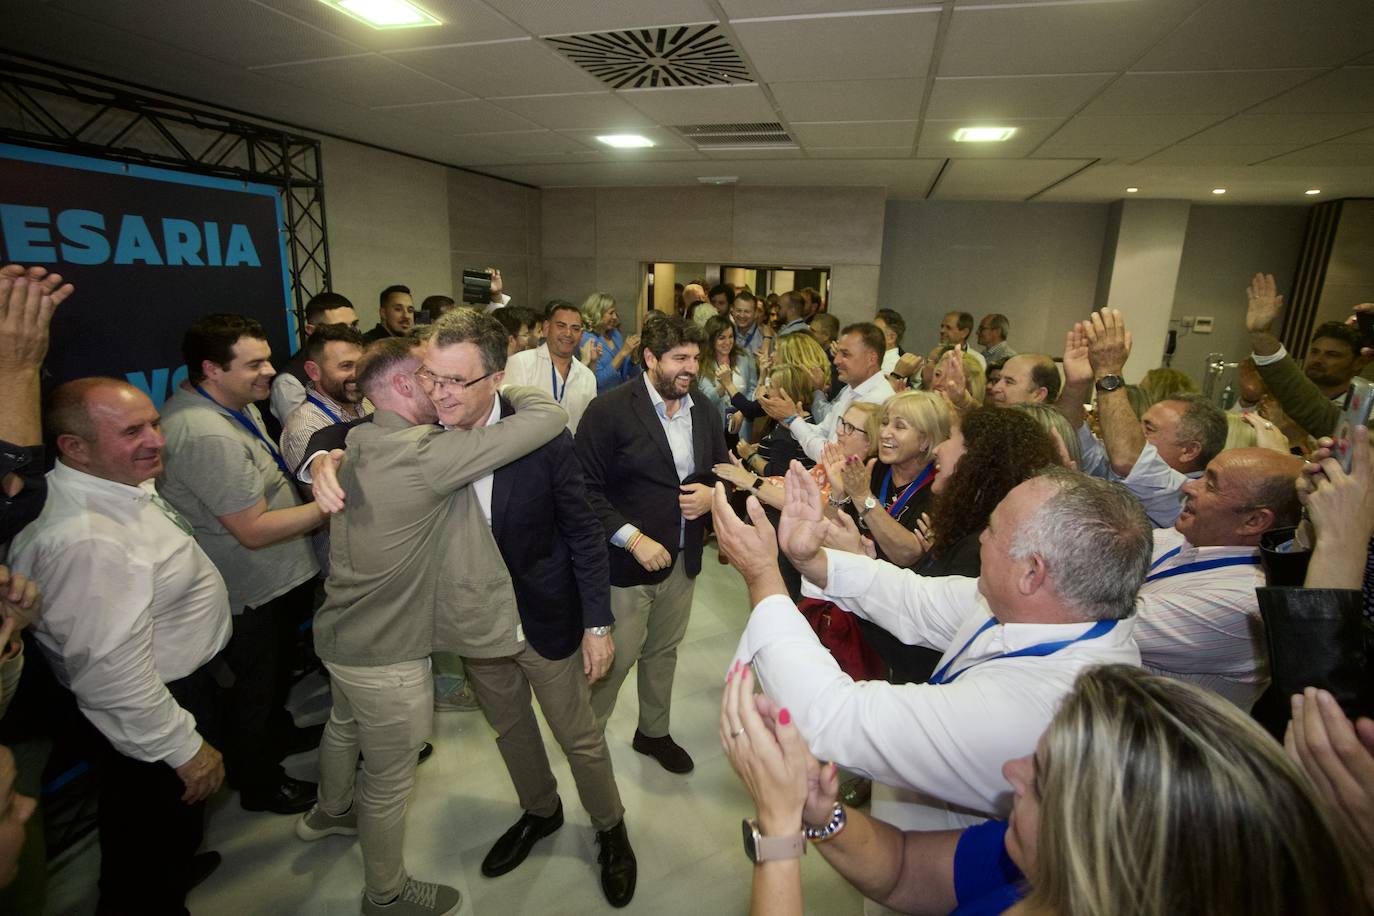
11;461;232;768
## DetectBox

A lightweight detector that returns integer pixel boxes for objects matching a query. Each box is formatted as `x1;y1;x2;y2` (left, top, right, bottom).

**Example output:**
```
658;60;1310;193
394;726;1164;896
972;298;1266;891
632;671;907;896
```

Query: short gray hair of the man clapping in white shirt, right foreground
1009;467;1154;621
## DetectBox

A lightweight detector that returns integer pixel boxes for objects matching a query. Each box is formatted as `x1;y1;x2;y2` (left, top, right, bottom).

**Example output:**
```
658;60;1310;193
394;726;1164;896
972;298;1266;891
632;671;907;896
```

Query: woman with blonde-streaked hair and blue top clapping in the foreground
720;665;1370;916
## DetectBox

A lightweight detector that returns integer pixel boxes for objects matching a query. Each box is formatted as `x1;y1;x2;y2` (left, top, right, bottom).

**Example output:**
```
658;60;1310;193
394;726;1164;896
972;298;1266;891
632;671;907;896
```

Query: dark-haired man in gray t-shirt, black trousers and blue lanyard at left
158;314;326;814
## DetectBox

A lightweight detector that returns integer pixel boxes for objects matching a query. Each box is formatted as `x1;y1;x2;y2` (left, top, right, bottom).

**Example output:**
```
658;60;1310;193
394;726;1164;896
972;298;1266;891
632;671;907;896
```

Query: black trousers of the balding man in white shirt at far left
96;665;223;916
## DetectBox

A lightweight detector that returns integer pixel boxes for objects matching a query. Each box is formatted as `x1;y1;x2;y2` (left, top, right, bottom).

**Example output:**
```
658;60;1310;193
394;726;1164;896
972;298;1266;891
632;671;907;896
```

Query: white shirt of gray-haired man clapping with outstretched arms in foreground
735;551;1140;829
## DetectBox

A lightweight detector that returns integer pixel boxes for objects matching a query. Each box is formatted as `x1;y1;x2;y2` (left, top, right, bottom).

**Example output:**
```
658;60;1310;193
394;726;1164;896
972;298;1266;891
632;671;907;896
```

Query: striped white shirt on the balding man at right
1135;529;1270;711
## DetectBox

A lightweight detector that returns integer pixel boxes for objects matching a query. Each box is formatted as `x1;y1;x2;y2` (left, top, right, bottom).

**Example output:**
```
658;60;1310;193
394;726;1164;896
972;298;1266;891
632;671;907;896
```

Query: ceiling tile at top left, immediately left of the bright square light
54;0;367;67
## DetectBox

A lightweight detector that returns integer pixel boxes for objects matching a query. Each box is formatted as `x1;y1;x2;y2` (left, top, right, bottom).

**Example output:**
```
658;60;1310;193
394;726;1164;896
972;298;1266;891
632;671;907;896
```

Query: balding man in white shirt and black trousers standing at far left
11;378;232;913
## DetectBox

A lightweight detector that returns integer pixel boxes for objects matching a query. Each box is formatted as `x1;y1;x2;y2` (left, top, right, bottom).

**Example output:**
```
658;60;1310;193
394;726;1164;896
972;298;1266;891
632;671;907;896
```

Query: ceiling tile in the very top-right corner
1132;0;1374;70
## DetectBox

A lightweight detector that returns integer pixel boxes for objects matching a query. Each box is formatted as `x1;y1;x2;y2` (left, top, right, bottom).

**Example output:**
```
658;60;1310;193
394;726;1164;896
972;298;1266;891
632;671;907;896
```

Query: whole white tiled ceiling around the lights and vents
0;0;1374;203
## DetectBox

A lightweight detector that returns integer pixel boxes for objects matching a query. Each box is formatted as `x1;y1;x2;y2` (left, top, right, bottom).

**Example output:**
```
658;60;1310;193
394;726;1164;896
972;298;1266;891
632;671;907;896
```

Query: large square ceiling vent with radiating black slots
547;25;754;89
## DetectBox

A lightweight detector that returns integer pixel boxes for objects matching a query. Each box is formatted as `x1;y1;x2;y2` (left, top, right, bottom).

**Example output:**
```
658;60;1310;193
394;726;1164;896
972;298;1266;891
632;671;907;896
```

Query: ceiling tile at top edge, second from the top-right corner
940;0;1195;77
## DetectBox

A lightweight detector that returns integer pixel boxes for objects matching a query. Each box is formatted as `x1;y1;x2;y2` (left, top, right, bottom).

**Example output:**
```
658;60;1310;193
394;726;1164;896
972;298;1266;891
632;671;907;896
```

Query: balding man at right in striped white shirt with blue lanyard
1135;449;1303;711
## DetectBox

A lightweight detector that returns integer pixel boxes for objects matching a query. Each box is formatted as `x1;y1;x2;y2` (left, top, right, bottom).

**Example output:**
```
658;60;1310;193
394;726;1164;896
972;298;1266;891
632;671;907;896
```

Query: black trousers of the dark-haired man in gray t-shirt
224;580;315;794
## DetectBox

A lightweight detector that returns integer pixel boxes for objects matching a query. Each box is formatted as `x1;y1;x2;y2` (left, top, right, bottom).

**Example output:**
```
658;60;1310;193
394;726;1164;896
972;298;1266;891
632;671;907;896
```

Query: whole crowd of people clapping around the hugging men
0;259;1374;916
